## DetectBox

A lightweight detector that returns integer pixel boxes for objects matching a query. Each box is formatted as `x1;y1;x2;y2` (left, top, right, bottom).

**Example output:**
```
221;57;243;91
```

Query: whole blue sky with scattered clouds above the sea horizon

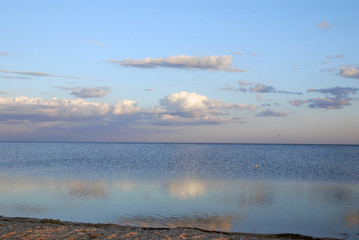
0;0;359;144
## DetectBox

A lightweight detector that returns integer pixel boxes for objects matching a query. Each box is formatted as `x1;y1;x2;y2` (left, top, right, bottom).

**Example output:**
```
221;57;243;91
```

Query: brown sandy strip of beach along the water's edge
0;217;340;240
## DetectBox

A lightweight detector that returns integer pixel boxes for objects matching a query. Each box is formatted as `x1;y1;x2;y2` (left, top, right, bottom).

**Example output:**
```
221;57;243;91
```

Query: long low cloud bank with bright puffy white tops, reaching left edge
0;92;257;126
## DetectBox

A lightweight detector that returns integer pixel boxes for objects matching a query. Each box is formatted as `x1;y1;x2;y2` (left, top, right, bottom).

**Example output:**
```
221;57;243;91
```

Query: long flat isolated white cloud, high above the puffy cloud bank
108;55;245;72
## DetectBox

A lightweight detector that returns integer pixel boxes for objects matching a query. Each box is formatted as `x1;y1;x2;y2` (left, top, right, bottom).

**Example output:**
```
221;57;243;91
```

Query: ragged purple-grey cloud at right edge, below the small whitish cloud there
289;87;359;109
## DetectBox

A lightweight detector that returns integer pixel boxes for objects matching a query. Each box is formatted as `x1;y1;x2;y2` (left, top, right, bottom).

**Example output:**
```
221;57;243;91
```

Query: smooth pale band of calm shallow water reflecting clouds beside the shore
0;175;359;236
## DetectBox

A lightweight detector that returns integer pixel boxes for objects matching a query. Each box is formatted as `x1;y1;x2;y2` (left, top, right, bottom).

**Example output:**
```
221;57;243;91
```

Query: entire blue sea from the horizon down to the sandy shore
0;142;359;239
